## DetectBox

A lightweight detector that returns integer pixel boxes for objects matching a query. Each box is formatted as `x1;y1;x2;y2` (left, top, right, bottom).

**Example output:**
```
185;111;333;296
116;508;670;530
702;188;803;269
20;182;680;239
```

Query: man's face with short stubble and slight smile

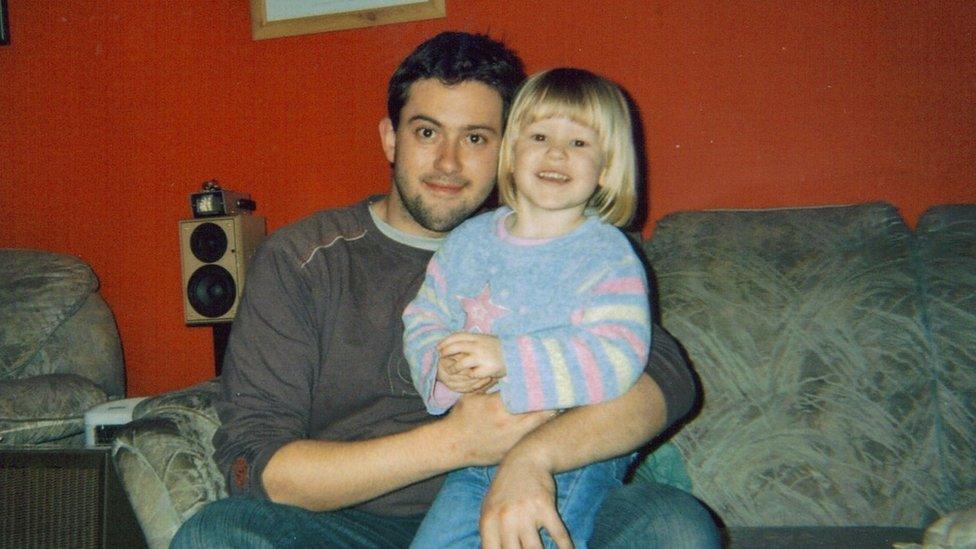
380;79;502;236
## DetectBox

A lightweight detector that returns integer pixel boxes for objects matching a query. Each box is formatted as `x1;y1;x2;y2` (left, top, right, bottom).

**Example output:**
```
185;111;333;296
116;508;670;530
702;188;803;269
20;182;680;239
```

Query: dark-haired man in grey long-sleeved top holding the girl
174;33;716;548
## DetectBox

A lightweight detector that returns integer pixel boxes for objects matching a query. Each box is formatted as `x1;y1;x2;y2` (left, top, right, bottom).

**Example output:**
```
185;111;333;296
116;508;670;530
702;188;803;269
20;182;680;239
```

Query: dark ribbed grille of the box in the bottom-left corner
0;462;103;548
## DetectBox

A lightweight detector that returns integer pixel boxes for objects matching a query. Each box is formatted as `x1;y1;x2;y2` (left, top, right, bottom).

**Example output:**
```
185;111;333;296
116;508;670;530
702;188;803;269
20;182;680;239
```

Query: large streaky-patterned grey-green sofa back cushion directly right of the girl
646;204;940;527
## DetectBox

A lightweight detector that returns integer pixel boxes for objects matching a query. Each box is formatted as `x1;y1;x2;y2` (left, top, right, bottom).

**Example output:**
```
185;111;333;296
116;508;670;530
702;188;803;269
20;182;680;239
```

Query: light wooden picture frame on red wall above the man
251;0;447;40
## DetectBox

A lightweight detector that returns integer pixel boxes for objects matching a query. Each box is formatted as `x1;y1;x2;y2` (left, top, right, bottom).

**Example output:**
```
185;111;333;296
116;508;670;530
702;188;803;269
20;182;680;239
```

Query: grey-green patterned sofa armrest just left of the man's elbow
112;381;227;548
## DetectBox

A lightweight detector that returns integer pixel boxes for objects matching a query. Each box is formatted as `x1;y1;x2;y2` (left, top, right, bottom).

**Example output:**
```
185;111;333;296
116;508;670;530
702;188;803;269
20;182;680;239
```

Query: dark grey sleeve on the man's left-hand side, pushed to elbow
213;237;320;499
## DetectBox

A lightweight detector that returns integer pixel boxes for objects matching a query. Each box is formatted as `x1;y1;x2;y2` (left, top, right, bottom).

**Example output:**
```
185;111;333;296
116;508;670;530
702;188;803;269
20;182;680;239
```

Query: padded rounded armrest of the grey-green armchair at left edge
0;374;108;446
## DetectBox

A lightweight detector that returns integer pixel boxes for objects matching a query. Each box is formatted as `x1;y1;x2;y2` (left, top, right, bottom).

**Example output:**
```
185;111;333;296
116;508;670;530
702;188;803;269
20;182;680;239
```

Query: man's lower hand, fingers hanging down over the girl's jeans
479;452;573;549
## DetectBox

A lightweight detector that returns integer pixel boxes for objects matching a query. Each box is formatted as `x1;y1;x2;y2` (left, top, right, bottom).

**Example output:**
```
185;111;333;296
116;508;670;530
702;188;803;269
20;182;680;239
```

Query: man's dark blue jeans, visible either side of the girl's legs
170;474;721;549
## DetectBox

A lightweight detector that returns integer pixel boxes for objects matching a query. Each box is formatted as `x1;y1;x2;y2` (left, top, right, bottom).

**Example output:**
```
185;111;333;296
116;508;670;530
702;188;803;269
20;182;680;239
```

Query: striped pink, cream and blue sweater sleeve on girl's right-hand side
499;249;651;413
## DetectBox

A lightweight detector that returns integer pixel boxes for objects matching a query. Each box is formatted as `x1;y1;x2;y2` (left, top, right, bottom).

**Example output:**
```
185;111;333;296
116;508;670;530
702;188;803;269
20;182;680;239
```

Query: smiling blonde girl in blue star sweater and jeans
403;69;651;548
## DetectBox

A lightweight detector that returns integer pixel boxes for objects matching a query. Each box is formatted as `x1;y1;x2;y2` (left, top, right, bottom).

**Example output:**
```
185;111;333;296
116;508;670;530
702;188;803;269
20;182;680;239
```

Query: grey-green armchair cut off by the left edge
0;249;125;450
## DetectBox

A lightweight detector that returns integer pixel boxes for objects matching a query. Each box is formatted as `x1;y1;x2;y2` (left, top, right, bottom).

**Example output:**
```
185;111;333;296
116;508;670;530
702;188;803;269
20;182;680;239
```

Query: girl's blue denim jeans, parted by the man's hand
410;457;631;549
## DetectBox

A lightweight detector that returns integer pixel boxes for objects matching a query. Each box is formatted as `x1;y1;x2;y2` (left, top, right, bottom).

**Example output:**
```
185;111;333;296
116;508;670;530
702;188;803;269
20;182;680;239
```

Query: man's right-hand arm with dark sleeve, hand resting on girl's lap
481;326;695;549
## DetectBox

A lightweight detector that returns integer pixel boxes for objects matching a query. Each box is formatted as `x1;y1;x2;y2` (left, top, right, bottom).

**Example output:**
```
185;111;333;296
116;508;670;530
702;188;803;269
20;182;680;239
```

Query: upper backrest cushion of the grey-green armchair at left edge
0;249;98;379
